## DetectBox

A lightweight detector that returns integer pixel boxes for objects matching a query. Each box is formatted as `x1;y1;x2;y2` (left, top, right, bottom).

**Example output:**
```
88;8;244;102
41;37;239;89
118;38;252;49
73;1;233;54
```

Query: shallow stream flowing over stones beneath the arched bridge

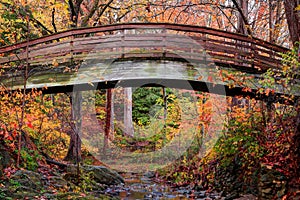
105;172;221;200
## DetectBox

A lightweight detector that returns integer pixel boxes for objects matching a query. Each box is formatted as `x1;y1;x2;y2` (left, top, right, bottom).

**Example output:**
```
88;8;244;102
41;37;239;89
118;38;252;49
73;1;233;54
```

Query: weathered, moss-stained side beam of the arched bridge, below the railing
1;58;298;101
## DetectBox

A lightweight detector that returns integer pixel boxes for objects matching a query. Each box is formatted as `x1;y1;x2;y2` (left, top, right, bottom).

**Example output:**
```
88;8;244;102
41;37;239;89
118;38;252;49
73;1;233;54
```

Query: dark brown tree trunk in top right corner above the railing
284;0;300;45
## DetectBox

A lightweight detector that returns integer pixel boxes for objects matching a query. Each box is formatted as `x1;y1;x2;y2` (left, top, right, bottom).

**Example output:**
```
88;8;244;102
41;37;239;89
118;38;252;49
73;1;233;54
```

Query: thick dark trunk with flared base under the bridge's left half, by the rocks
64;91;82;163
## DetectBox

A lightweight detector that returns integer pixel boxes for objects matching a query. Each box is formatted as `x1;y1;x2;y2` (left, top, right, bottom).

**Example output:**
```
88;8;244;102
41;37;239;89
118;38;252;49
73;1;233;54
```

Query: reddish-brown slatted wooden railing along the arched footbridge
0;23;288;73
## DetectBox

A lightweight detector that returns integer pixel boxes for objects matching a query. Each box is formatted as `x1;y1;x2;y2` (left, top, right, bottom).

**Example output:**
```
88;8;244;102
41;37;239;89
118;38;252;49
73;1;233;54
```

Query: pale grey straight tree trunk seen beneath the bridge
124;87;134;137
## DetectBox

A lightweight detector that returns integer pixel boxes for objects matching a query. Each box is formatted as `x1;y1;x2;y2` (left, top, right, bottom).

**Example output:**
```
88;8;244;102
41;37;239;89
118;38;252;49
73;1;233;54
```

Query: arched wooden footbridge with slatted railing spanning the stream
0;23;296;97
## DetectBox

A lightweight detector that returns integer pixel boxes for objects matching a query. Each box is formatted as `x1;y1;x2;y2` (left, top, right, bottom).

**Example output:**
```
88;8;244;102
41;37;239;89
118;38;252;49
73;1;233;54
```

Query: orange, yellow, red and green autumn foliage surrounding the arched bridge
0;0;300;199
